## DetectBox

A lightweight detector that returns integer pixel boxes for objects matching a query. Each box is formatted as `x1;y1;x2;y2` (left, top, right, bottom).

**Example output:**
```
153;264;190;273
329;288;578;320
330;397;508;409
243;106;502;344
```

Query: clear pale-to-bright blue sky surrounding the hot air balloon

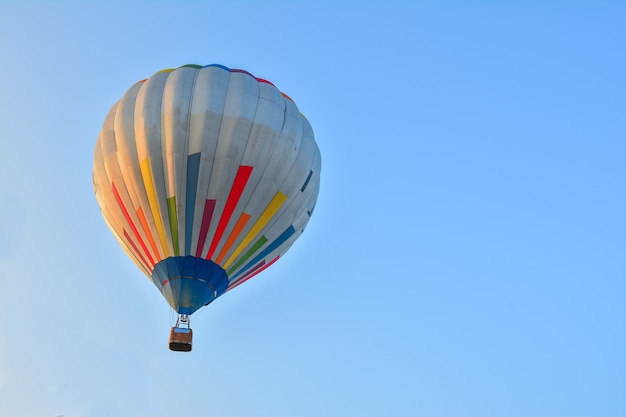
0;0;626;417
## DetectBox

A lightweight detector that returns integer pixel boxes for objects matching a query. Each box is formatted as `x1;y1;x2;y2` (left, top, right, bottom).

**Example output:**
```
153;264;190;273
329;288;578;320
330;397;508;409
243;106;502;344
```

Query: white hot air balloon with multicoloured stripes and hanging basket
93;65;321;351
